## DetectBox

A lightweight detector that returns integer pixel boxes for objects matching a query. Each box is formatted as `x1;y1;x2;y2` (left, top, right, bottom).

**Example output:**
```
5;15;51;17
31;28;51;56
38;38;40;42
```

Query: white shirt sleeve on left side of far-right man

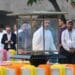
61;31;69;50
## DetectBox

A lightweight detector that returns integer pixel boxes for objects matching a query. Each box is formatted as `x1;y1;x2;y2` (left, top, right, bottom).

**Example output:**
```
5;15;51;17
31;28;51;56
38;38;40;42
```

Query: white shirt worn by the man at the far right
62;29;75;51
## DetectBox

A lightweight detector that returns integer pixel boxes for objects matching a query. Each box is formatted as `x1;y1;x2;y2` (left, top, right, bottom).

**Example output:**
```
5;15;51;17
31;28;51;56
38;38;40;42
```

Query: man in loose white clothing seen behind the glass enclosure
32;19;56;52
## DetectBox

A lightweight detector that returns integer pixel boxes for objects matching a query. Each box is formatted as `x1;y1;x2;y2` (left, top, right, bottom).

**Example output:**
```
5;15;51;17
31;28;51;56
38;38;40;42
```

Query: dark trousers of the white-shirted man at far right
58;47;75;64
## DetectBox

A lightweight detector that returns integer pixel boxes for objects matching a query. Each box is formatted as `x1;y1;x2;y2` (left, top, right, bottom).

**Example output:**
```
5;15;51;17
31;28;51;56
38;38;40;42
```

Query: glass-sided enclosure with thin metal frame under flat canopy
17;16;58;54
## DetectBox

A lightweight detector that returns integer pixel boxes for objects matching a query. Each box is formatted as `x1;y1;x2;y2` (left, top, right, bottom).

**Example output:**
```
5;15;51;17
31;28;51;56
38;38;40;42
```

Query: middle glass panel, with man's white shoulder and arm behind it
32;18;44;54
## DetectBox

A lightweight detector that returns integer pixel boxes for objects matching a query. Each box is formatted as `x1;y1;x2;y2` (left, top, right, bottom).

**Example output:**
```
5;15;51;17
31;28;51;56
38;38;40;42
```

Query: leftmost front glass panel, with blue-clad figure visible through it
18;16;32;54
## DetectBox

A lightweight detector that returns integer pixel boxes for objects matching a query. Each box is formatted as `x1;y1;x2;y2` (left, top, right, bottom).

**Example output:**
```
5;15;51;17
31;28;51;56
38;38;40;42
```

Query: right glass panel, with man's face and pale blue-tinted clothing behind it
44;18;57;51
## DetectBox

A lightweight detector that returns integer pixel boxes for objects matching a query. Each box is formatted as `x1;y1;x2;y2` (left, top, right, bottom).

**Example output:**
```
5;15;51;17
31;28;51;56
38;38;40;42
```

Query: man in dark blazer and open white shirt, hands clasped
1;25;16;50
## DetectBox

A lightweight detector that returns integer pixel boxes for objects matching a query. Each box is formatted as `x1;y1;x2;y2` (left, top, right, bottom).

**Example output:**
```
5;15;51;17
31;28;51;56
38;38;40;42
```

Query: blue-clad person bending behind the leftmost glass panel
18;23;31;50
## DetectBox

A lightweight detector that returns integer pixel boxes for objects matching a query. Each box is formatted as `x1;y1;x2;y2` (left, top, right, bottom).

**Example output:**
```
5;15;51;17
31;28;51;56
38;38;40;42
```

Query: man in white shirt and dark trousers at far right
61;20;75;64
